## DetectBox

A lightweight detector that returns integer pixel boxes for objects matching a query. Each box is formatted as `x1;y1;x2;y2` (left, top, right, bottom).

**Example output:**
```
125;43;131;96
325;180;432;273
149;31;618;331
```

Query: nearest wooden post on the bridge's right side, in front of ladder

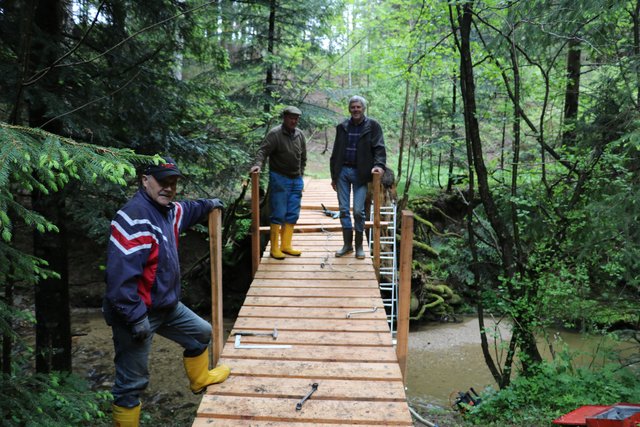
396;210;413;384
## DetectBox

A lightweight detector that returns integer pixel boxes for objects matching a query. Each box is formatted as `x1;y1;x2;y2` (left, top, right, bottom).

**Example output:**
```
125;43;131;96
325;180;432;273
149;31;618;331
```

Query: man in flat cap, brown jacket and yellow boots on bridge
250;106;307;260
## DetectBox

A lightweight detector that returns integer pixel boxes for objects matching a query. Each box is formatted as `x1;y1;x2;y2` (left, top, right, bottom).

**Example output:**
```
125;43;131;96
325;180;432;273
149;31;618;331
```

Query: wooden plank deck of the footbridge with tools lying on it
193;180;413;427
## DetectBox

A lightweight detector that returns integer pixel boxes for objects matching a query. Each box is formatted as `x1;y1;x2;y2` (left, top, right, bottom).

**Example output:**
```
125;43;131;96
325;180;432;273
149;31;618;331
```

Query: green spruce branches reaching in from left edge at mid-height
0;122;157;284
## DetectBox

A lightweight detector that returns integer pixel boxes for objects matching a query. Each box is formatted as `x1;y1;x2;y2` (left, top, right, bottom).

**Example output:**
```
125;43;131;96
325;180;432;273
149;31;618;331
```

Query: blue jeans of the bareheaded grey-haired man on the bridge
336;166;367;232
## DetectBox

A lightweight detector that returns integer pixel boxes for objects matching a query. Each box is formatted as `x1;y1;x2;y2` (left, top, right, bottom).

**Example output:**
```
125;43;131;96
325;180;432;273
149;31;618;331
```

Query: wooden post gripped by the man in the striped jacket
209;209;224;366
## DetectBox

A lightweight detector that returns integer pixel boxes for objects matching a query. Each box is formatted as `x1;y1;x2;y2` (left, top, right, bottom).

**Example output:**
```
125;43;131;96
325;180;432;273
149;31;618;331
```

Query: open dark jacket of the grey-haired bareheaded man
329;117;387;183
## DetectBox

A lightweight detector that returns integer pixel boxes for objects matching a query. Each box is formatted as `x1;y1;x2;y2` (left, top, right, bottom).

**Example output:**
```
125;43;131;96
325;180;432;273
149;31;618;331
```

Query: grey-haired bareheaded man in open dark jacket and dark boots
330;96;387;259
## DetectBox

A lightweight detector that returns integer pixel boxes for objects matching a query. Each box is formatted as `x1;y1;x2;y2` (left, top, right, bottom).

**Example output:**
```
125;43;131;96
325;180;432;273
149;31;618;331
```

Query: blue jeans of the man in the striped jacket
111;302;211;408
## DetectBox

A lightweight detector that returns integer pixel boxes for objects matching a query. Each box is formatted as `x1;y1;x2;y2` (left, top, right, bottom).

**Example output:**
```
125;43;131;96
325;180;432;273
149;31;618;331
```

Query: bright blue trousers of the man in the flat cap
269;172;304;224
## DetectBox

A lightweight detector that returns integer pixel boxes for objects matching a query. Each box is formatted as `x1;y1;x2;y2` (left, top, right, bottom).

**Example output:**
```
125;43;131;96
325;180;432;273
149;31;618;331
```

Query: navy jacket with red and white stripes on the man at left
105;189;213;323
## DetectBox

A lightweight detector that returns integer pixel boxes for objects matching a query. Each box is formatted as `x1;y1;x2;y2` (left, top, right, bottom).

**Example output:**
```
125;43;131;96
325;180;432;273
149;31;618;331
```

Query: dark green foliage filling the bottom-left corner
0;373;111;427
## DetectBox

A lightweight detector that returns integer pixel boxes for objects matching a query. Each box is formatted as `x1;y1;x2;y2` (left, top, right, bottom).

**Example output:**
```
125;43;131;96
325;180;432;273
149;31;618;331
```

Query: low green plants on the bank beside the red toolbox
467;350;640;426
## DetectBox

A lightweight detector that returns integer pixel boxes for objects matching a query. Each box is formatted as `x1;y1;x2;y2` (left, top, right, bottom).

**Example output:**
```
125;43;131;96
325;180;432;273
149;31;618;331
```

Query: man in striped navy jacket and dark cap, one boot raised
103;157;230;427
